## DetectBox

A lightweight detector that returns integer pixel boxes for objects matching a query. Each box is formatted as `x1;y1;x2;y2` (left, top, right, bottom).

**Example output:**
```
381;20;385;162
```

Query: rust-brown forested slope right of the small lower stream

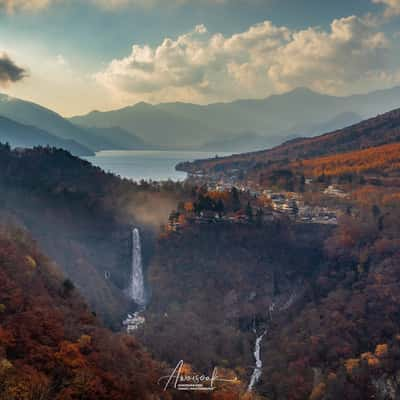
260;188;400;400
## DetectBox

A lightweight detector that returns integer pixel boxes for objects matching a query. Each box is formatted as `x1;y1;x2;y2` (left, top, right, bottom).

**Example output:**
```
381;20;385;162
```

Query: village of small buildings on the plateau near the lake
167;172;348;232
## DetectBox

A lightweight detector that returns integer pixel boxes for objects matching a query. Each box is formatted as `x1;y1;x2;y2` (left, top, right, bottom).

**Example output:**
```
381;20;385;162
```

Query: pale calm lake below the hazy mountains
84;150;230;181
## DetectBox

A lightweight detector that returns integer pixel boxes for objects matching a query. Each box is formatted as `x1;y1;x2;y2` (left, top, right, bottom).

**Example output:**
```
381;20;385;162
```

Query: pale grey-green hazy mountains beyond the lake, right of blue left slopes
70;87;400;148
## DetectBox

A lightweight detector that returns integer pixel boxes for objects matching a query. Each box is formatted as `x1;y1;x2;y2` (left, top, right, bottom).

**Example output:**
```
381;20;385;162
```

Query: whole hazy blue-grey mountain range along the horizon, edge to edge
0;87;400;155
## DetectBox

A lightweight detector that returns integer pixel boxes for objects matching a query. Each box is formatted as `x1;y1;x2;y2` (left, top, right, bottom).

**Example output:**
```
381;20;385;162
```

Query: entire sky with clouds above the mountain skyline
0;0;400;116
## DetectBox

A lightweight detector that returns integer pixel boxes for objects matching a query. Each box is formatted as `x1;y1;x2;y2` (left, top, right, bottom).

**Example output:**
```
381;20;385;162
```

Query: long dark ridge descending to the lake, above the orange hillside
177;108;400;172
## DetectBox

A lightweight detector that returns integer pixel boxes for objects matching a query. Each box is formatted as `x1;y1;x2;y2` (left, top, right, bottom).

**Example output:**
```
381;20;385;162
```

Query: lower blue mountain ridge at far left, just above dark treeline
0;116;93;156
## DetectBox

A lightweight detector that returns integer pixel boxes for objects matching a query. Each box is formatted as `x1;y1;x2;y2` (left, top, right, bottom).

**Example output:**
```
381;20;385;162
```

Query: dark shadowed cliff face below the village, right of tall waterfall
139;222;329;380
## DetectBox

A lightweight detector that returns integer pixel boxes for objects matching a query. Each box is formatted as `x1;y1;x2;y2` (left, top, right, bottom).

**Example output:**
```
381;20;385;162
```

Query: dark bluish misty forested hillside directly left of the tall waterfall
0;146;189;329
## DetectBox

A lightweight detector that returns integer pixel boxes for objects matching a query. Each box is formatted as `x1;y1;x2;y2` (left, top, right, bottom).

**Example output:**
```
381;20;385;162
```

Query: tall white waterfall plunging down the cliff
129;228;146;306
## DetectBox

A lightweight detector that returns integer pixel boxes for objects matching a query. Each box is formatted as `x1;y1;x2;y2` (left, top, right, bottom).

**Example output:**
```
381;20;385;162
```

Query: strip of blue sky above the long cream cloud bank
0;0;381;63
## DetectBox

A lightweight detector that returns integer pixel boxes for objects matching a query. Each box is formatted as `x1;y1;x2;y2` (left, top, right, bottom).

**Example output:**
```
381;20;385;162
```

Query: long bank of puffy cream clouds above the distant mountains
96;16;389;103
